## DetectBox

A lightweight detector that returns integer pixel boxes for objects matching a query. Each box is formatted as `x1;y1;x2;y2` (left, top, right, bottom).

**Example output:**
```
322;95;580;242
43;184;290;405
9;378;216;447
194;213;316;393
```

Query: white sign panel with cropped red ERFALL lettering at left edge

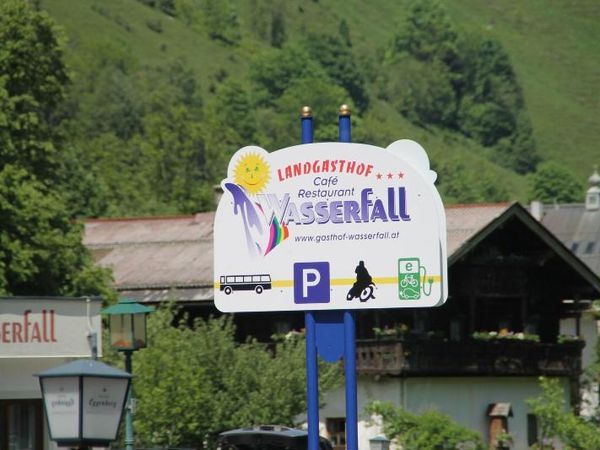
0;297;102;358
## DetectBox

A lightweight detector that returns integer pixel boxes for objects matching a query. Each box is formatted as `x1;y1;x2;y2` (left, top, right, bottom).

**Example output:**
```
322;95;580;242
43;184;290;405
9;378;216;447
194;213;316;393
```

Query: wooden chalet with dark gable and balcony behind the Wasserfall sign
85;203;600;448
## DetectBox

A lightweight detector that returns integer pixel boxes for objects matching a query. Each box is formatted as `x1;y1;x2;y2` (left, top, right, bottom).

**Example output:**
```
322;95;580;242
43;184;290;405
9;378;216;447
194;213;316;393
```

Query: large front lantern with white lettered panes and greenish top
36;359;131;449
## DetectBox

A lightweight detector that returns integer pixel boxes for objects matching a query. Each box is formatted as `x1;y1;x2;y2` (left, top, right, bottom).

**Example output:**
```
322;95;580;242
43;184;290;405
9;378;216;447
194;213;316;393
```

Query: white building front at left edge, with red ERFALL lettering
0;297;102;450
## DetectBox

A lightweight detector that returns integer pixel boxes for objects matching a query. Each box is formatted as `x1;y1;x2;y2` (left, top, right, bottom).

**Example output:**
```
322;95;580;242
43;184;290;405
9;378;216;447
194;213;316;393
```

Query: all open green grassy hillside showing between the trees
41;0;600;212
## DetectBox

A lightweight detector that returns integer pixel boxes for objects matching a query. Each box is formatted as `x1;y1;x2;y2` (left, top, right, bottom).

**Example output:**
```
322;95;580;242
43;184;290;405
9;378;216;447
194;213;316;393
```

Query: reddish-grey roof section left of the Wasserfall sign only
84;212;214;300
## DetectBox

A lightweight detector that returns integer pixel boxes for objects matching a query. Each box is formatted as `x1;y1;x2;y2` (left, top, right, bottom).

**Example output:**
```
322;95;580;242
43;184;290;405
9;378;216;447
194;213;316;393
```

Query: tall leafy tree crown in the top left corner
0;0;68;184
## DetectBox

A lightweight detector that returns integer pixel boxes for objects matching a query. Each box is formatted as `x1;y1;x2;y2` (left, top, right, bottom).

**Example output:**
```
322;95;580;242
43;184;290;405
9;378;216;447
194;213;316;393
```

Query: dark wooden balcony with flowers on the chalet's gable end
357;339;585;377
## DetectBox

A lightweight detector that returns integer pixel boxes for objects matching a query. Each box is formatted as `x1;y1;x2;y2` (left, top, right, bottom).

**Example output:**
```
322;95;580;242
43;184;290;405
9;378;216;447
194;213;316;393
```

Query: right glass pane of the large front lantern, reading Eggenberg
83;377;128;441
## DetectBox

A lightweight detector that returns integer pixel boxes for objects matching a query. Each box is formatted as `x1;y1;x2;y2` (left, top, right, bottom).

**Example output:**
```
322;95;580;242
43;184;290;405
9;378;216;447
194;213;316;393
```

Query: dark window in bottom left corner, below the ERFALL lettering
0;400;43;450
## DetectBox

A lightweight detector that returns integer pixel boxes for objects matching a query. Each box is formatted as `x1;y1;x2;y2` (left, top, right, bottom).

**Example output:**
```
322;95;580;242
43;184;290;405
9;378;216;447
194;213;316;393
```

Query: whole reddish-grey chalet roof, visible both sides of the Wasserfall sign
84;203;600;303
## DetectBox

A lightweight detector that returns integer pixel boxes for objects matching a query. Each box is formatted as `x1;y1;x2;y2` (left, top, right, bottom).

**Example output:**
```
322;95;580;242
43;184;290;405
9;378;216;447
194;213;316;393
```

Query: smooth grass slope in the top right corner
445;0;600;181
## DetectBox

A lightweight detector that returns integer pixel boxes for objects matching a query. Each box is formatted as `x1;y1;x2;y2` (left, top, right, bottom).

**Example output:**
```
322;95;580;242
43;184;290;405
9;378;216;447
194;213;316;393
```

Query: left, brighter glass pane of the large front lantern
41;377;79;439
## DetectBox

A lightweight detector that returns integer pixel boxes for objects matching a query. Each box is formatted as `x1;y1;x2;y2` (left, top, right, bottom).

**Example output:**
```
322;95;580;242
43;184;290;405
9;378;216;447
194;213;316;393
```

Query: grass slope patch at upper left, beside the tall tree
41;0;247;89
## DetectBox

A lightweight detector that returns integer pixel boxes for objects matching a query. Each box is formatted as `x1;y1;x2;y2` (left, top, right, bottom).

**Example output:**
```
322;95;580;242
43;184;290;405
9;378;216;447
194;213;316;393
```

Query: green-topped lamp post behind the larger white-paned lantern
101;298;154;450
